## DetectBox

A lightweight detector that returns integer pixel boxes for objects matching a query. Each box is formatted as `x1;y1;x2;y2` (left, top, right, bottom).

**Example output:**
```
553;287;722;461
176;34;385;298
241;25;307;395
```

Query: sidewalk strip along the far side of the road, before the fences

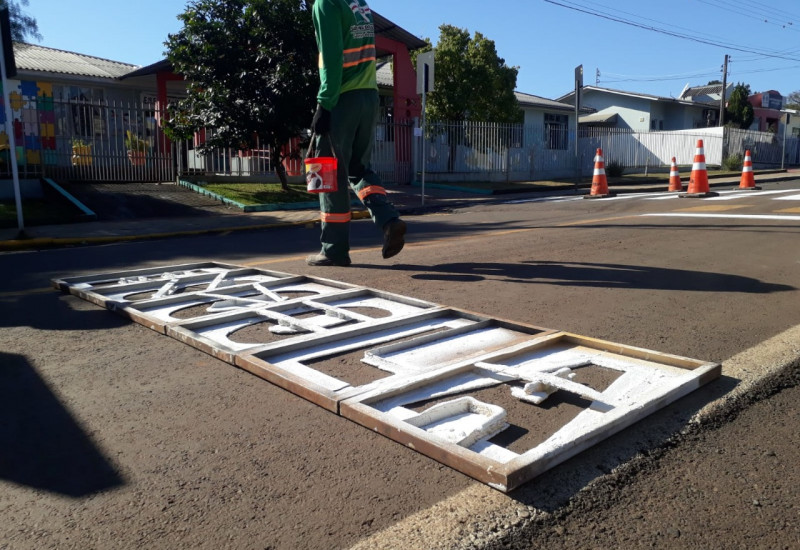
0;171;800;252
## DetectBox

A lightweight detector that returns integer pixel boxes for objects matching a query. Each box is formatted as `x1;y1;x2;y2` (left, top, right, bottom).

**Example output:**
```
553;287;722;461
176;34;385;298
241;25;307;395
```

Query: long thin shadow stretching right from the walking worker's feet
358;261;796;294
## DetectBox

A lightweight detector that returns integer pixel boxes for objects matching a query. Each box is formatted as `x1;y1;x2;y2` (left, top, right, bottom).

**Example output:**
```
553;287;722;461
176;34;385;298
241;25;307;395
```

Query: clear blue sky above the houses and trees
23;0;800;99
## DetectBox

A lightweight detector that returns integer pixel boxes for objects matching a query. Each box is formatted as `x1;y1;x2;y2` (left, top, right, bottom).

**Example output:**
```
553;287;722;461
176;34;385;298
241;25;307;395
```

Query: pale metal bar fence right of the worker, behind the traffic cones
415;122;800;181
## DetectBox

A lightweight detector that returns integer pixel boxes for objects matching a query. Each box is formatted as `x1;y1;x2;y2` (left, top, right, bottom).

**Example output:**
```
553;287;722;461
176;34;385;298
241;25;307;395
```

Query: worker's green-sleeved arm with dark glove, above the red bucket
313;0;344;111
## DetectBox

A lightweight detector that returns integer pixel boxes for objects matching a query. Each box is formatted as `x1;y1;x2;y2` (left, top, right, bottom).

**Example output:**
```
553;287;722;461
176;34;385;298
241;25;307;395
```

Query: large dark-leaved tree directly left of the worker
165;0;318;190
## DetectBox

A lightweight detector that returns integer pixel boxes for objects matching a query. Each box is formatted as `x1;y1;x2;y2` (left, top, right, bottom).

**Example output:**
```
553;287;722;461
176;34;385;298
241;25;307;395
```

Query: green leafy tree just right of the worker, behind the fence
423;25;522;122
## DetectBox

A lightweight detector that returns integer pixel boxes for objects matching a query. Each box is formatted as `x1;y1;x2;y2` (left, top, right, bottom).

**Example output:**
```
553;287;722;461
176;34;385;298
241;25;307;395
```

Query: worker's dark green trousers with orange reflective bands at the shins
315;90;398;261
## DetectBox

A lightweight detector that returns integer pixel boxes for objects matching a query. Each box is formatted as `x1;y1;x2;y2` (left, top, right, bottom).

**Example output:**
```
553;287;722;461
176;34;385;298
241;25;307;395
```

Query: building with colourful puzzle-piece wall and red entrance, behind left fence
0;12;426;181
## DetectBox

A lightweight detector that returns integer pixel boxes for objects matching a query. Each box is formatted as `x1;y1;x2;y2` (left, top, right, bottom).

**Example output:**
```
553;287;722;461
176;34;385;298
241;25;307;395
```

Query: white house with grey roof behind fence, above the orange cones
556;86;714;132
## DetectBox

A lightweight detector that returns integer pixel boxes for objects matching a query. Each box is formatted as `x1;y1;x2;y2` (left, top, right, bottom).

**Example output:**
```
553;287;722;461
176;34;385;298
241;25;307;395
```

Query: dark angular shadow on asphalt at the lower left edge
0;352;124;497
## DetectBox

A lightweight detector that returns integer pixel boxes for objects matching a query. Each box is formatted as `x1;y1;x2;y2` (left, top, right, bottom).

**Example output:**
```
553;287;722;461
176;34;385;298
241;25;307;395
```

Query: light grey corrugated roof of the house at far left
14;42;138;78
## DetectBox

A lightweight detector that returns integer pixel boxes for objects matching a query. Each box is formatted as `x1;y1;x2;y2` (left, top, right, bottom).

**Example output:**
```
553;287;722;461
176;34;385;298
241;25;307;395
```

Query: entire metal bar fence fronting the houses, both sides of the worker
0;98;800;184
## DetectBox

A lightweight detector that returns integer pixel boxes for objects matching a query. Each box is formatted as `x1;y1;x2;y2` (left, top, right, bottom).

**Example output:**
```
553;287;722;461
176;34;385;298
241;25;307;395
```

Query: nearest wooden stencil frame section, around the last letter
339;332;721;492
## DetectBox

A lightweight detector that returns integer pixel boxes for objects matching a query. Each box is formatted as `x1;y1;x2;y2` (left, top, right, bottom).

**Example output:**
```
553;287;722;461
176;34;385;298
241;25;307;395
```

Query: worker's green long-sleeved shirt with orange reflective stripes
312;0;378;111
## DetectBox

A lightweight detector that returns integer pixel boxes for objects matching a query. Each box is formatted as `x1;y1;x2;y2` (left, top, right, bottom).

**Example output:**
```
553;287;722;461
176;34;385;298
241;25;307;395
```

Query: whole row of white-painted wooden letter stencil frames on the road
52;262;721;491
